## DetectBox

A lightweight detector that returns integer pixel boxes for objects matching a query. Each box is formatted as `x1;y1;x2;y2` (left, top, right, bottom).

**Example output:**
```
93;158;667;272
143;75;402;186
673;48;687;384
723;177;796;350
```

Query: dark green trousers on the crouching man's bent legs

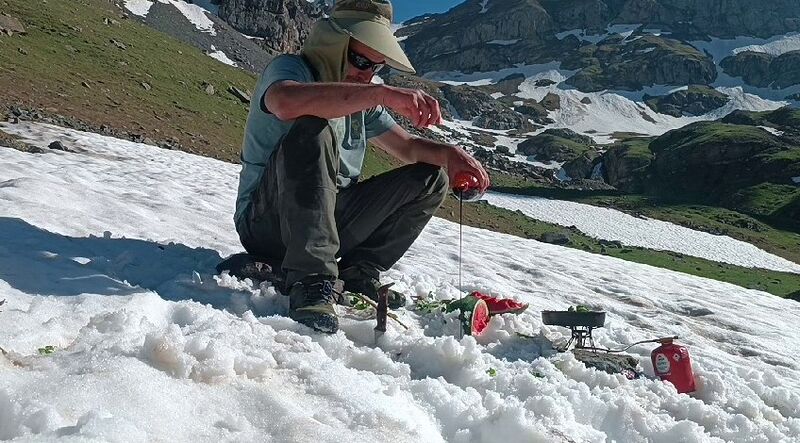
240;117;448;286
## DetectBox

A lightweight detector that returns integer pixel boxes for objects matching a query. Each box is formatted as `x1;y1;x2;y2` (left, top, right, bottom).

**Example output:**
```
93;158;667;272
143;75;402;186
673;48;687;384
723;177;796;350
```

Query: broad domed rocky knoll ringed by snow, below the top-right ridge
562;35;717;92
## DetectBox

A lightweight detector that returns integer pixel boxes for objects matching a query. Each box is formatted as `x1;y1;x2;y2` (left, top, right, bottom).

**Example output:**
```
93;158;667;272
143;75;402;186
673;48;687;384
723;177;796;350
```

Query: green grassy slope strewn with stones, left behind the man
0;0;255;161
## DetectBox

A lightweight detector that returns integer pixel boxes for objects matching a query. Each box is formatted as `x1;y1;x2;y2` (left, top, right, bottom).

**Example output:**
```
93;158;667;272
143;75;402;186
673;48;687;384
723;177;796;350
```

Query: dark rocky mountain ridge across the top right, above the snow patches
398;0;800;91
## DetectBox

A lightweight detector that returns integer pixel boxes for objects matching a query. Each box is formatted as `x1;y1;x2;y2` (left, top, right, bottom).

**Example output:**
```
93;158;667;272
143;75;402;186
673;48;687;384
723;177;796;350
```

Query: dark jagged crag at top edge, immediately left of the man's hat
219;0;326;53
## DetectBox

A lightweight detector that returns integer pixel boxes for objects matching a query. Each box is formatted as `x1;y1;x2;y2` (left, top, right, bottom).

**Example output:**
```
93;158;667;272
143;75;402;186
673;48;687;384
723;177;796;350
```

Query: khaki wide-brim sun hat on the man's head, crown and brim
330;0;416;74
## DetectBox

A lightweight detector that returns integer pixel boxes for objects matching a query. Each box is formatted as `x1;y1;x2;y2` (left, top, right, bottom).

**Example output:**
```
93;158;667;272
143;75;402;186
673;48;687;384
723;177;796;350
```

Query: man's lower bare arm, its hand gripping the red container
371;125;490;192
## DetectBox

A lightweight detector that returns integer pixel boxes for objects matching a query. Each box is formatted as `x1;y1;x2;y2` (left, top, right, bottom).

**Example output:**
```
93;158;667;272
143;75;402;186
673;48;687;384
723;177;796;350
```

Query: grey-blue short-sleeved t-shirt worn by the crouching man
234;55;396;227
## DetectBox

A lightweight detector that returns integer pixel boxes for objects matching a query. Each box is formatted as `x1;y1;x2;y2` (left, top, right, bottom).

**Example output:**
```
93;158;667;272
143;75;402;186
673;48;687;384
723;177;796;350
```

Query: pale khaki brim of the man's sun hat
331;18;417;74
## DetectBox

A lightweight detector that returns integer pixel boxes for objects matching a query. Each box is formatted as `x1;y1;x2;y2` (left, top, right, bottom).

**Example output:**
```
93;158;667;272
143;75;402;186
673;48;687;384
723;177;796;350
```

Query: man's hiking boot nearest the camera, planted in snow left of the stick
289;275;339;334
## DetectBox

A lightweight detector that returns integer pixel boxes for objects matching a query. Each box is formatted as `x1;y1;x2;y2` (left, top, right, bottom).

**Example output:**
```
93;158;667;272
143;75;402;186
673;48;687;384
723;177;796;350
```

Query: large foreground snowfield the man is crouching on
0;123;800;443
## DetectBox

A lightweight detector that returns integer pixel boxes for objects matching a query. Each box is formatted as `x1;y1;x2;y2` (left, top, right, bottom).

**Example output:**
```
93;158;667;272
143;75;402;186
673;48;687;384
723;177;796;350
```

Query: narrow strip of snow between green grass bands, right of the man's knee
485;192;800;274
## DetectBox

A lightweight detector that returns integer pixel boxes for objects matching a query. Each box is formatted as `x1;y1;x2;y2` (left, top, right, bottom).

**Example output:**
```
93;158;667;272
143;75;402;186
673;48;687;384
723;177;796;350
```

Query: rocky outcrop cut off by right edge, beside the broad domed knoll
720;51;800;89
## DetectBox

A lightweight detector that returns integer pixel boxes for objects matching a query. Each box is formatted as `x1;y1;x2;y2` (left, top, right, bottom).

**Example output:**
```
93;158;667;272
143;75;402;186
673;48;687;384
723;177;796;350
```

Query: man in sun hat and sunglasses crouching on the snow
235;0;489;332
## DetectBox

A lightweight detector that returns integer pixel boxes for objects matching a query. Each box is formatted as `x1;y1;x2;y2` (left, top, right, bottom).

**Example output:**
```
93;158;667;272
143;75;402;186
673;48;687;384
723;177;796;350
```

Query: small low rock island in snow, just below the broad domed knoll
644;85;730;117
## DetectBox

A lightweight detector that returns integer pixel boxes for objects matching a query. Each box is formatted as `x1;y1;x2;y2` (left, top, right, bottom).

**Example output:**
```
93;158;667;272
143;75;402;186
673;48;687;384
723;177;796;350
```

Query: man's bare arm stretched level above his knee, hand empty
264;80;442;127
